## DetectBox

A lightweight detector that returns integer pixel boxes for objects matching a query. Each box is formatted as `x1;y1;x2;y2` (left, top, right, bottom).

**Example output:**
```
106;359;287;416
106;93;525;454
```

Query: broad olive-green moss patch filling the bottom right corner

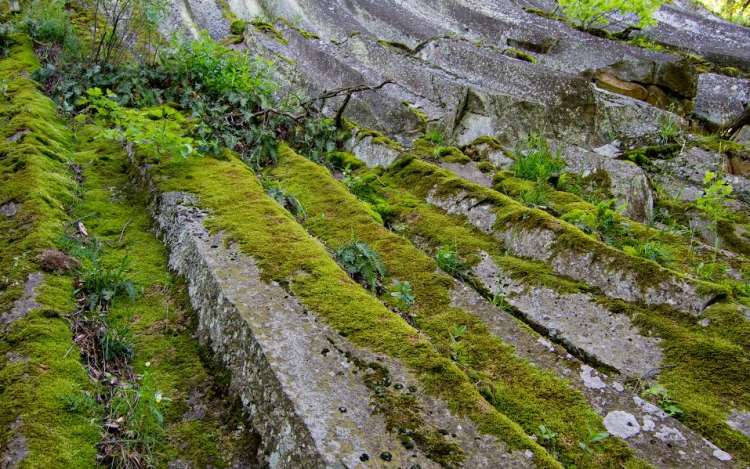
603;300;750;461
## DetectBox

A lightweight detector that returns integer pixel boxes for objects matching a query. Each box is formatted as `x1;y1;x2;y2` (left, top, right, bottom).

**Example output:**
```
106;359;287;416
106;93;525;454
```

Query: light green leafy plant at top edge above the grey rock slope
558;0;665;29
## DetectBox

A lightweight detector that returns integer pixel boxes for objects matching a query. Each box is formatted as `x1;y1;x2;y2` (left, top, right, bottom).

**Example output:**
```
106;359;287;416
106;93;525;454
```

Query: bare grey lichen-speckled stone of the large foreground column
132;163;532;468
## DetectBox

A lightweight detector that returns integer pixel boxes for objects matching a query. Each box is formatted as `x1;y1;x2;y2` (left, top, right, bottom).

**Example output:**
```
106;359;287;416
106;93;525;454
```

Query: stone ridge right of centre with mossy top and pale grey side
388;155;726;314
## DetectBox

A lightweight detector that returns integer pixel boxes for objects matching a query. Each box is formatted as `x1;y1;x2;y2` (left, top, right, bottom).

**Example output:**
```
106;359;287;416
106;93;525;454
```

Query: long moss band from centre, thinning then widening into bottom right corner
346;147;750;460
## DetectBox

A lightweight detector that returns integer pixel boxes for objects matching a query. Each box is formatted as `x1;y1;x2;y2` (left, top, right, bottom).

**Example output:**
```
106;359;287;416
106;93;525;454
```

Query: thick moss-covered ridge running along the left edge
0;37;99;468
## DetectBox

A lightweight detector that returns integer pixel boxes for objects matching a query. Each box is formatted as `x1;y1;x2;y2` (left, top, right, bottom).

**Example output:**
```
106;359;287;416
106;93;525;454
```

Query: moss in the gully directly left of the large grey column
72;126;259;468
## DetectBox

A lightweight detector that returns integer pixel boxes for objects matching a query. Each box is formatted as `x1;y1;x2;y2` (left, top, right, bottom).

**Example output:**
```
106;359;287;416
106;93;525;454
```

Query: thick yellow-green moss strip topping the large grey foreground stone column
132;144;559;467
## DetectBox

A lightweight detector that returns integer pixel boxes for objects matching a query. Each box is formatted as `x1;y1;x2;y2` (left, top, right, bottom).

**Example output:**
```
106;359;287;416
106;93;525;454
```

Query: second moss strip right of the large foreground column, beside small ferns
269;150;648;467
